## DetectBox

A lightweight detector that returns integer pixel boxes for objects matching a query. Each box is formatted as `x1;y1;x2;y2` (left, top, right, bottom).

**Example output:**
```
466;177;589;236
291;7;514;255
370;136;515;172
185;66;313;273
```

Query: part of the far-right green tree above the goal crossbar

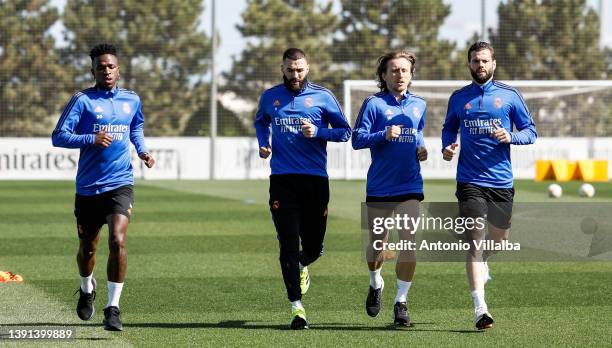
489;0;611;80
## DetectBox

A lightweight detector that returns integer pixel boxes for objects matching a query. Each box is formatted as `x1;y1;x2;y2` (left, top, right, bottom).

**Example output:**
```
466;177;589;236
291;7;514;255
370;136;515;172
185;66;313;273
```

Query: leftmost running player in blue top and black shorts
52;44;155;331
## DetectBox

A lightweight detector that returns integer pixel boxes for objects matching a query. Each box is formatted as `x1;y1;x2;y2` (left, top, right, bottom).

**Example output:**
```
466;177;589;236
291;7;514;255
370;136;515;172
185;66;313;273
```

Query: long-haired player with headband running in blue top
352;51;427;326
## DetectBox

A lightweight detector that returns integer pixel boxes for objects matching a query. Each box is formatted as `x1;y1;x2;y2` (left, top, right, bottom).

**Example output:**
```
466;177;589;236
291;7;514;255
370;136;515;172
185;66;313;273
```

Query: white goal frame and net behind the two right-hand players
344;80;612;179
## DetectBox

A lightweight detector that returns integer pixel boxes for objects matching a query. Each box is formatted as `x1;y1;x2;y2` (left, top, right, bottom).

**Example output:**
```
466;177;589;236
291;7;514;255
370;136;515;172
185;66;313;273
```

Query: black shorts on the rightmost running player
455;182;514;229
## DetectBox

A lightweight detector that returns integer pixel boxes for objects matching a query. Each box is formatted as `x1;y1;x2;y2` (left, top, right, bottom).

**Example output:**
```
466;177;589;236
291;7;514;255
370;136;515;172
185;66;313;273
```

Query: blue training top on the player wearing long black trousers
254;82;351;177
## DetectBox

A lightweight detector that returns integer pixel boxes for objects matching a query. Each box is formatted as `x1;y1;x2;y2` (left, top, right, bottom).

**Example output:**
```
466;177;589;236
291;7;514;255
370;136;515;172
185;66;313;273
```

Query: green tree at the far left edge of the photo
0;0;68;136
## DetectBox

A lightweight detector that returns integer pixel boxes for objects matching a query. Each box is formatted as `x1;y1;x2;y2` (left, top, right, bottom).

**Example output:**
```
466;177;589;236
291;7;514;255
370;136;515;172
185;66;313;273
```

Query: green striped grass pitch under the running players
0;180;612;346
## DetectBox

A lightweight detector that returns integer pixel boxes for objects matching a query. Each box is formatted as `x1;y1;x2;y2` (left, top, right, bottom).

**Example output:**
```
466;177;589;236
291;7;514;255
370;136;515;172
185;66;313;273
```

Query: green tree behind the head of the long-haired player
333;0;464;80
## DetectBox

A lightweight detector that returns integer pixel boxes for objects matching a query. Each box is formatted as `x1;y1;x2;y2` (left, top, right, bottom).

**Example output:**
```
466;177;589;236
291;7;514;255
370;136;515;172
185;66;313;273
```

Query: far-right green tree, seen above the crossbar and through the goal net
489;0;612;136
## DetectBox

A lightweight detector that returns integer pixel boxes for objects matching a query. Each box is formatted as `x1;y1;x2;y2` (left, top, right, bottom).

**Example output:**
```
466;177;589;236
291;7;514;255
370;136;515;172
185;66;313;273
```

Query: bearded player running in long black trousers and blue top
254;48;351;329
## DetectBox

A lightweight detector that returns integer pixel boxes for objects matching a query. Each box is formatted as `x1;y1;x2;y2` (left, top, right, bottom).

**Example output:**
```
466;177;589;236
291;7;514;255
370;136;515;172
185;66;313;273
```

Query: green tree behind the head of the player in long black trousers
224;0;340;103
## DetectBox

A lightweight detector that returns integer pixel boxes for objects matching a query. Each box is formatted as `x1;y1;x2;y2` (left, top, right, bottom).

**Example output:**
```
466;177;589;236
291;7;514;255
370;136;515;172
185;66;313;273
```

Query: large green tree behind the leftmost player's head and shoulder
63;0;210;135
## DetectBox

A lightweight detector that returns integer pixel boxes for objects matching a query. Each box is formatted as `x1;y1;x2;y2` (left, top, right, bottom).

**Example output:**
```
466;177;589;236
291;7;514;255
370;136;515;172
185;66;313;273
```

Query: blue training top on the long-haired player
352;92;427;197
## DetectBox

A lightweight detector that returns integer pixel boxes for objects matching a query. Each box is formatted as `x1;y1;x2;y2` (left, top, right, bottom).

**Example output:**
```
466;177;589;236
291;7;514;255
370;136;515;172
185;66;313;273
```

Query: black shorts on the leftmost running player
74;185;134;238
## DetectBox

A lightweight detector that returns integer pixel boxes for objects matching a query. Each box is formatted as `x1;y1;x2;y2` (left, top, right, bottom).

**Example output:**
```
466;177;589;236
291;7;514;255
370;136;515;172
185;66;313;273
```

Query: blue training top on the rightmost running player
442;80;537;188
